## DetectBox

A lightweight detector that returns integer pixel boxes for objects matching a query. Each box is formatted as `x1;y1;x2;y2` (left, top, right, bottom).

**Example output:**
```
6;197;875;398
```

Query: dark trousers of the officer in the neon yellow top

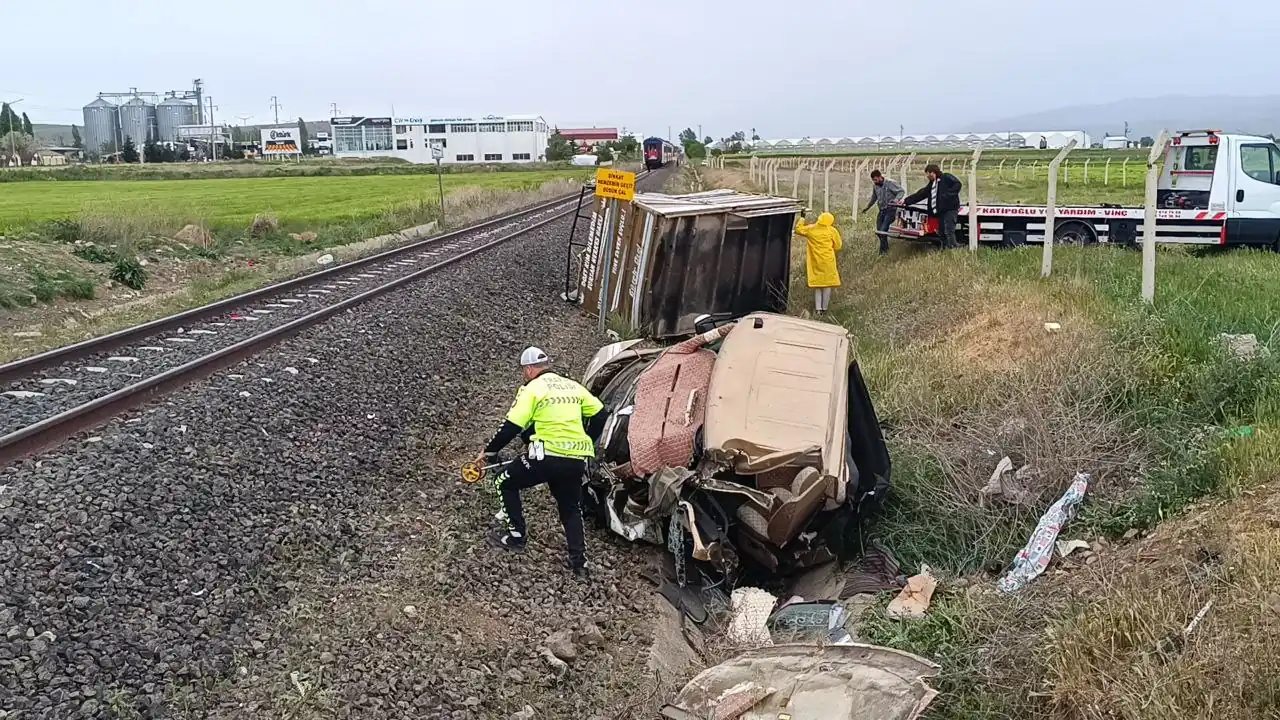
498;455;586;568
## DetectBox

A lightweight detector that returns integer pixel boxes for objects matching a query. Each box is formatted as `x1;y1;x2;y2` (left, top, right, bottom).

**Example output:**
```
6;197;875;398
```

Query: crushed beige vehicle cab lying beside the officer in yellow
582;313;891;584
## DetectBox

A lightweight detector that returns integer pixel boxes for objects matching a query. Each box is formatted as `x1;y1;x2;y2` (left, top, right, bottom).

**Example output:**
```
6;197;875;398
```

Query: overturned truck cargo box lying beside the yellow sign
577;190;800;338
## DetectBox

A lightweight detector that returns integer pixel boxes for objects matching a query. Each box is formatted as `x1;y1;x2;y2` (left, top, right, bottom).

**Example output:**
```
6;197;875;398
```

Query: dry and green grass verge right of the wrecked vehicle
704;163;1280;720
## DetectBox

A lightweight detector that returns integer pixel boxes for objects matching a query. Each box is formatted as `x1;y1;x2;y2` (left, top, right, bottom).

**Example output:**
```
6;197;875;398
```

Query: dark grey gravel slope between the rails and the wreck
0;211;670;719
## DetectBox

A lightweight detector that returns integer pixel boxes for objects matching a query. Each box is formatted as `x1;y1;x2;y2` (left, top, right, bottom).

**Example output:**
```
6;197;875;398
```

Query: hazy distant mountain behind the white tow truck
966;95;1280;142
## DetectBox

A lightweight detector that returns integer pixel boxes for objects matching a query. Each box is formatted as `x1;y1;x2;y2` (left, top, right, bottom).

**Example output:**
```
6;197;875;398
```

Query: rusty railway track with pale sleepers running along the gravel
0;167;653;465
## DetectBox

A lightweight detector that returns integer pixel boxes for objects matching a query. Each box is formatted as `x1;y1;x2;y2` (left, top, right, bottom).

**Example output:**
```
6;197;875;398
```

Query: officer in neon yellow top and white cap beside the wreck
480;347;604;579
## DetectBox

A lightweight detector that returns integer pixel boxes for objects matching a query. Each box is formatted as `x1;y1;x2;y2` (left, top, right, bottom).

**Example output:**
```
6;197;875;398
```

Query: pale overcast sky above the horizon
0;0;1280;137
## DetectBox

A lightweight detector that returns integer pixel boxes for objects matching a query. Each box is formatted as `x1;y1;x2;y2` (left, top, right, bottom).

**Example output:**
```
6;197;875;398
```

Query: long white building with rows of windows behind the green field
329;115;549;164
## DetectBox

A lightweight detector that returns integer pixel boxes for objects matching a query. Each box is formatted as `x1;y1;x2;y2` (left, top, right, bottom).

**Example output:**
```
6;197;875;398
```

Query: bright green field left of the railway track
0;169;586;234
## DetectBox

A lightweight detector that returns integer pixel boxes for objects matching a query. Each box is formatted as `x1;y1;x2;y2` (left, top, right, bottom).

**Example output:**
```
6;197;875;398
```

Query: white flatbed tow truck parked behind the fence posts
890;131;1280;251
